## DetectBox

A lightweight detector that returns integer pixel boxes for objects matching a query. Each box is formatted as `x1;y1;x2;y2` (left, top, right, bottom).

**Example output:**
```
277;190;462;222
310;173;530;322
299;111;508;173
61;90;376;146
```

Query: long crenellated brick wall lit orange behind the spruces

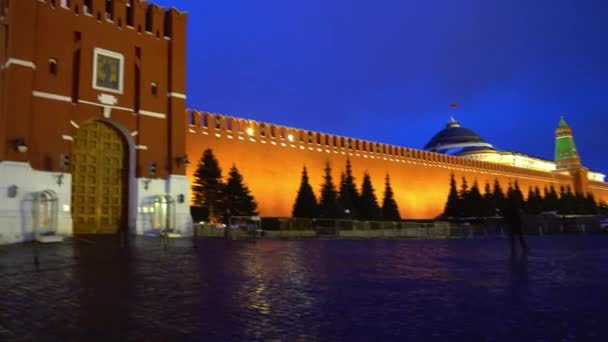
186;112;608;218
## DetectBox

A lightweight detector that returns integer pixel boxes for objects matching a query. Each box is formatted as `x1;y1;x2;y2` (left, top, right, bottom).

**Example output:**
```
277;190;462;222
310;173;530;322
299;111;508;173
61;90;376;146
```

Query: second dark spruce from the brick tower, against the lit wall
223;165;258;216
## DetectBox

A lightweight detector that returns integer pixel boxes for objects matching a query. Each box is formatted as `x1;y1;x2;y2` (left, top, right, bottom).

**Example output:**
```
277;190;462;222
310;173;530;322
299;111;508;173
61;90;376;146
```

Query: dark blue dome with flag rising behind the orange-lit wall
424;118;494;154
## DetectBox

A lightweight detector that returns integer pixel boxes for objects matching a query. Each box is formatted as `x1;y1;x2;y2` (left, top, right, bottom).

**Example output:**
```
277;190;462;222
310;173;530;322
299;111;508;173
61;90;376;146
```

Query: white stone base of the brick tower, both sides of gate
0;161;192;245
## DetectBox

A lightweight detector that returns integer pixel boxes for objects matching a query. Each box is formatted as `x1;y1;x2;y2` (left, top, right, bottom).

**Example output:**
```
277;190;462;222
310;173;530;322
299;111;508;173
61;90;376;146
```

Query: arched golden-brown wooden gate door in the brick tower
72;121;128;234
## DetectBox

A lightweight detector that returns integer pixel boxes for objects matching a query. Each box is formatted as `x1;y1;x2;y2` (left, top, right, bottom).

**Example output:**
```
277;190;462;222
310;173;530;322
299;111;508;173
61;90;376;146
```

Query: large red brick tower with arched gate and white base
0;0;191;243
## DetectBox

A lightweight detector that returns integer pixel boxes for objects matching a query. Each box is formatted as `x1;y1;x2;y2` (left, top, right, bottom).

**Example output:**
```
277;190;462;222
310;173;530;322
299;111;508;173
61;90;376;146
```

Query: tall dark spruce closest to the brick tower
192;149;223;221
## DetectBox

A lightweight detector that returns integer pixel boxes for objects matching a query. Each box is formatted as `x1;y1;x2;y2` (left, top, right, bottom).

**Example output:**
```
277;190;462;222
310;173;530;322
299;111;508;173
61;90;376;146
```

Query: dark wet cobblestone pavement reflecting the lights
0;235;608;341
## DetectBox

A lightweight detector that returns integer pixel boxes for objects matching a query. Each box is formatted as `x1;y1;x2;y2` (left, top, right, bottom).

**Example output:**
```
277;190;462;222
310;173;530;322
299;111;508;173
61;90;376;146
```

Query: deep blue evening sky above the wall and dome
154;0;608;172
